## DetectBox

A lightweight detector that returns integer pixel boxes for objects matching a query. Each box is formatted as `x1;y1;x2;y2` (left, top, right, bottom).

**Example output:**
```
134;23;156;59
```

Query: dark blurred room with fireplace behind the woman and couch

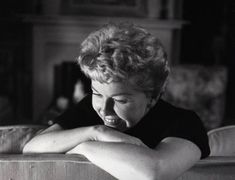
0;0;235;129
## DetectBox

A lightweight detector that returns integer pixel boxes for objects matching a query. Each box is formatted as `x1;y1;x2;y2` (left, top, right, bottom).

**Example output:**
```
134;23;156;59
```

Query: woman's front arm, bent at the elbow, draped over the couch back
68;129;201;180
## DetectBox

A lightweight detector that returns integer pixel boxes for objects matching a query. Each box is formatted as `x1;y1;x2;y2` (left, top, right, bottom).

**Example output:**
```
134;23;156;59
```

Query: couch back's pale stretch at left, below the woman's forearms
0;154;114;180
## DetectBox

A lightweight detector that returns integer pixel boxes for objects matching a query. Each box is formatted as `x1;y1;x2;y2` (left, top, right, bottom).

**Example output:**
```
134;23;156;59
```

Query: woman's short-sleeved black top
55;95;210;158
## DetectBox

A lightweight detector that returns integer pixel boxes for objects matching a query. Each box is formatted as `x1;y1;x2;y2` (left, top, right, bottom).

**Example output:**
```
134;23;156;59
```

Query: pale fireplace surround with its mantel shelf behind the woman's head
24;16;185;122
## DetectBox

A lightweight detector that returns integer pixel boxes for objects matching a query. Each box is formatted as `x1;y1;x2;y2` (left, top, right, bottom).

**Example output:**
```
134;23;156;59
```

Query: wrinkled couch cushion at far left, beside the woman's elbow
0;125;45;154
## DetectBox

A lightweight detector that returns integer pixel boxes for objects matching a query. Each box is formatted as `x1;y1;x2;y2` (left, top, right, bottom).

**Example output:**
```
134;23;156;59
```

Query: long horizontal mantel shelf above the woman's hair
24;15;186;29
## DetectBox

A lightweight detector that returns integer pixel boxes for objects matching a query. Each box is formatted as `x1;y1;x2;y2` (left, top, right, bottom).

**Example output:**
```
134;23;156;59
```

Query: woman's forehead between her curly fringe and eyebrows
91;80;139;96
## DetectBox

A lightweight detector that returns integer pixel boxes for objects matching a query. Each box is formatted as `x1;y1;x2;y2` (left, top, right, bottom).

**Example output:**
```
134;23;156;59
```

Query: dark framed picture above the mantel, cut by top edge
61;0;147;17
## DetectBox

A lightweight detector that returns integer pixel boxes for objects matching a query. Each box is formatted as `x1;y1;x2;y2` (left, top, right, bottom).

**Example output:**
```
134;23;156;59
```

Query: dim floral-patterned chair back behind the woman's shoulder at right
163;65;227;130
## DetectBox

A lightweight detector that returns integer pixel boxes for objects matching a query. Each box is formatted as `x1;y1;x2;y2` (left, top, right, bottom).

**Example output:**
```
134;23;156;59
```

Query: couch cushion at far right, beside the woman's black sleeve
208;125;235;156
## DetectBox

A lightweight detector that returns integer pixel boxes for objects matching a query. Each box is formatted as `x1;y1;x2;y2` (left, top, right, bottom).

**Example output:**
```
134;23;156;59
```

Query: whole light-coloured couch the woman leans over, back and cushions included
0;125;235;180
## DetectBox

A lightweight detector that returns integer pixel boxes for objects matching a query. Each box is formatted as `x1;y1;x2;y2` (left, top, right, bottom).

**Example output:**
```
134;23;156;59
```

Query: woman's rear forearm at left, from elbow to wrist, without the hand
23;124;93;153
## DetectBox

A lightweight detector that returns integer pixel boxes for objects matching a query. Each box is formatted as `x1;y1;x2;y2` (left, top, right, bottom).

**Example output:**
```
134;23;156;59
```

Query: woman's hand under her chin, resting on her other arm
90;125;147;147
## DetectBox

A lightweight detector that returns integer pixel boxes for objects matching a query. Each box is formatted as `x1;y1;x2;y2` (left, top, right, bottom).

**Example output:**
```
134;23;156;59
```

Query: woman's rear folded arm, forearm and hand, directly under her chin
23;124;145;153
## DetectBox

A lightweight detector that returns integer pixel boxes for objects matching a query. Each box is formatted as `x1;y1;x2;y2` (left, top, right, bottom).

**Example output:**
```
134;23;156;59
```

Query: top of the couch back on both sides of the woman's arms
0;154;235;180
